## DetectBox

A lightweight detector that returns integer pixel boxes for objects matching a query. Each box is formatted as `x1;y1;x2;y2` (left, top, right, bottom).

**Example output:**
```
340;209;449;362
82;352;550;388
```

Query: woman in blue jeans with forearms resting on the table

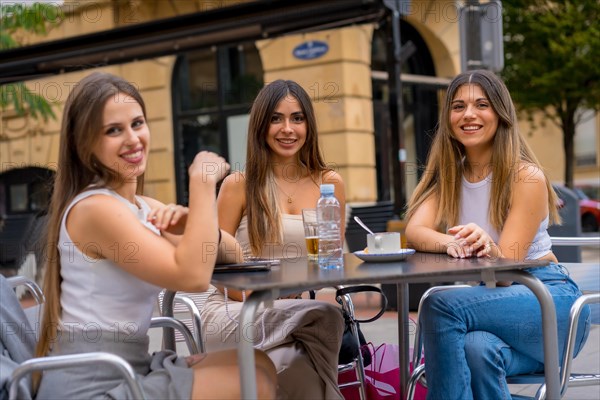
406;70;590;400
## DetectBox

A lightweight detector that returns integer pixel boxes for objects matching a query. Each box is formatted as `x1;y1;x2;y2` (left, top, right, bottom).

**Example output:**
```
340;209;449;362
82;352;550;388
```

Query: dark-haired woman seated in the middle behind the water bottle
202;80;345;399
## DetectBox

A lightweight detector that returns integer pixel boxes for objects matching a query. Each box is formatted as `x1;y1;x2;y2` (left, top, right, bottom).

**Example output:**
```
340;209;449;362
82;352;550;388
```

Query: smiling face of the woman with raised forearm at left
94;93;150;182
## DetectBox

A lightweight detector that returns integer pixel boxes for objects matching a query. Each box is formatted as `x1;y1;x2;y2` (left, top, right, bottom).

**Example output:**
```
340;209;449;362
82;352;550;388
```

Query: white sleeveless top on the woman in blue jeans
458;174;552;260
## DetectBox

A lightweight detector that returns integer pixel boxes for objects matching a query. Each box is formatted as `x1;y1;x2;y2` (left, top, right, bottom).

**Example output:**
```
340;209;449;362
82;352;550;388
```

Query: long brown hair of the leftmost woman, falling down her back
36;72;146;362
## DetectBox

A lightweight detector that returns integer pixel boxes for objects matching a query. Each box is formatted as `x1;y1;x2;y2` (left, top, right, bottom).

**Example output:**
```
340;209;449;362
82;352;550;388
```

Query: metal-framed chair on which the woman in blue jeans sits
407;237;600;400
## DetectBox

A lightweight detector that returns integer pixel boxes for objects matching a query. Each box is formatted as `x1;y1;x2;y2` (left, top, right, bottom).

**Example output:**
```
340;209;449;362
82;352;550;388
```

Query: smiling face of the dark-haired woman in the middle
267;95;307;161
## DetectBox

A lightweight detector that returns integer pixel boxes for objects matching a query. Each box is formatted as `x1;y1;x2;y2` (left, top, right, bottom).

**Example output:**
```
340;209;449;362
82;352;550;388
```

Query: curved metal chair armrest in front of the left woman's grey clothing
9;352;146;400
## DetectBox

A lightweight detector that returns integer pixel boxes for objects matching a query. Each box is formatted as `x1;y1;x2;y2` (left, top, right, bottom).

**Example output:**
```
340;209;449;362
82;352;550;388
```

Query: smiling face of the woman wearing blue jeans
450;84;498;152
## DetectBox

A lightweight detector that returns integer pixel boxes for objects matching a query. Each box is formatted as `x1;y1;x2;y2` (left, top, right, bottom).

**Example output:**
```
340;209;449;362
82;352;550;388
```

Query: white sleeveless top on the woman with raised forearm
58;189;161;340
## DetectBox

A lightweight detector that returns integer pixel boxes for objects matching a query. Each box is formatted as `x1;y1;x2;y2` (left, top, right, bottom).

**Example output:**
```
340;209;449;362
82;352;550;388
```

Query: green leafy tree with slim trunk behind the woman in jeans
502;0;600;187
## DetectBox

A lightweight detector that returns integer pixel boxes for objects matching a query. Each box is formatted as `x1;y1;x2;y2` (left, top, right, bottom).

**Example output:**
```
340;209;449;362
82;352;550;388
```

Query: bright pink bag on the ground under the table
338;343;427;400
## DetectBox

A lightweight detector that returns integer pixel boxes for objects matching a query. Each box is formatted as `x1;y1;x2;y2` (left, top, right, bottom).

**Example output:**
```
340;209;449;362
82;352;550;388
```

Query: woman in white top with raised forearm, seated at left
36;72;276;399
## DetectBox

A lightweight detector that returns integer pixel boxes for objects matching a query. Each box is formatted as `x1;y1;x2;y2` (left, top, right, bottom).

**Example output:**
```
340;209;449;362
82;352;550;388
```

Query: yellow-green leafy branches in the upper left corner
0;2;61;120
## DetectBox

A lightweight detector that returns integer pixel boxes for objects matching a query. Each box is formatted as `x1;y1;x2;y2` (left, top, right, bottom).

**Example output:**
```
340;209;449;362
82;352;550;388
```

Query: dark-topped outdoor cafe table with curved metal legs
207;252;560;399
